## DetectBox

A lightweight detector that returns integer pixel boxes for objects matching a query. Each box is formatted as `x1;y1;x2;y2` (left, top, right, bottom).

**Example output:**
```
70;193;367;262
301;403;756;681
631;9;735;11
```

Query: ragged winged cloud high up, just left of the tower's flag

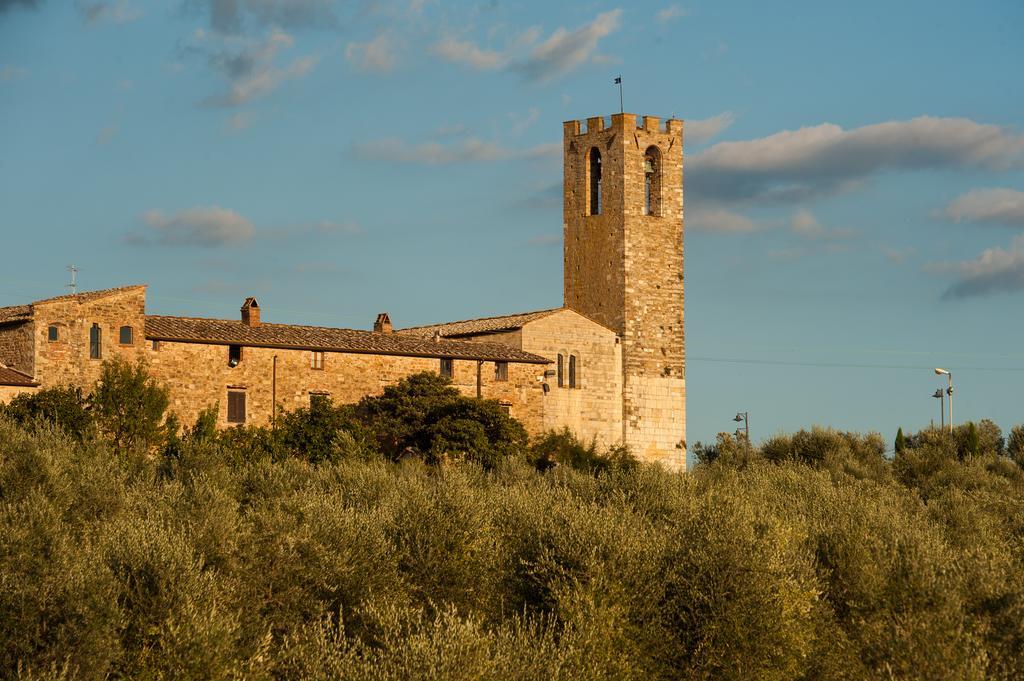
430;9;622;81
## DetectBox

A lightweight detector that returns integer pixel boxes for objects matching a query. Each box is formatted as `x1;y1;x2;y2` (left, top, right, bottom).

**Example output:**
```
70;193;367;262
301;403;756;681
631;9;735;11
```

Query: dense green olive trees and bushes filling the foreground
0;368;1024;679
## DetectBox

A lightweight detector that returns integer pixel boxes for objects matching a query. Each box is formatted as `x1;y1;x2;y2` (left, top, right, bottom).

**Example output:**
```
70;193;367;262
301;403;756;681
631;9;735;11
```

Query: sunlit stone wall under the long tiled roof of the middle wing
146;341;544;431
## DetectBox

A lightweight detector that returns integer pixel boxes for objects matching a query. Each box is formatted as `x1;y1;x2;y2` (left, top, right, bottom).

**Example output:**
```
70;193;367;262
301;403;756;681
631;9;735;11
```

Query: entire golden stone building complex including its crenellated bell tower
0;114;686;468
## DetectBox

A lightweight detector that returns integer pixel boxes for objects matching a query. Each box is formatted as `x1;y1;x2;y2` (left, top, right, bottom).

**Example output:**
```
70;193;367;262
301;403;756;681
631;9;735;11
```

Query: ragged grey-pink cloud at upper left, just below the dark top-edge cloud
189;29;319;107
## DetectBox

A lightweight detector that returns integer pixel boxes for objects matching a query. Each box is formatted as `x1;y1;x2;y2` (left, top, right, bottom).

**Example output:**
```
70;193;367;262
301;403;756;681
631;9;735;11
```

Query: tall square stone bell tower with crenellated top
562;114;686;468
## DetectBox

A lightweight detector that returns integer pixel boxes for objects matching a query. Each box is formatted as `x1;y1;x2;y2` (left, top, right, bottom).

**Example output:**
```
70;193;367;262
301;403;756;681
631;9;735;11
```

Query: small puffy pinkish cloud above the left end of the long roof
138;206;255;246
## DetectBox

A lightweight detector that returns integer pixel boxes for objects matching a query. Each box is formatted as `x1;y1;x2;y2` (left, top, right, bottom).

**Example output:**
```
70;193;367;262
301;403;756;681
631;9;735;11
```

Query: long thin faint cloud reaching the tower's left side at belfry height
351;137;562;166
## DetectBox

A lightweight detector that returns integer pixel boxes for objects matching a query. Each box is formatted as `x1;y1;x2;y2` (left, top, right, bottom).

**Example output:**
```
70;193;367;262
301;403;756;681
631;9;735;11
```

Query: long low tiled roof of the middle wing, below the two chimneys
145;314;550;365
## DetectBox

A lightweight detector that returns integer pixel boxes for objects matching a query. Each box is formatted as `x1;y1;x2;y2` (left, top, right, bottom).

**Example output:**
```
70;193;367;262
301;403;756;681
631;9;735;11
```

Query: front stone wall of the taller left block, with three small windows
33;286;145;391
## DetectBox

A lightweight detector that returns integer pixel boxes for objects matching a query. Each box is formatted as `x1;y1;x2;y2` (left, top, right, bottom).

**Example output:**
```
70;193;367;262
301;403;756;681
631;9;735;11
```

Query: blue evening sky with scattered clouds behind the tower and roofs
0;0;1024;450
